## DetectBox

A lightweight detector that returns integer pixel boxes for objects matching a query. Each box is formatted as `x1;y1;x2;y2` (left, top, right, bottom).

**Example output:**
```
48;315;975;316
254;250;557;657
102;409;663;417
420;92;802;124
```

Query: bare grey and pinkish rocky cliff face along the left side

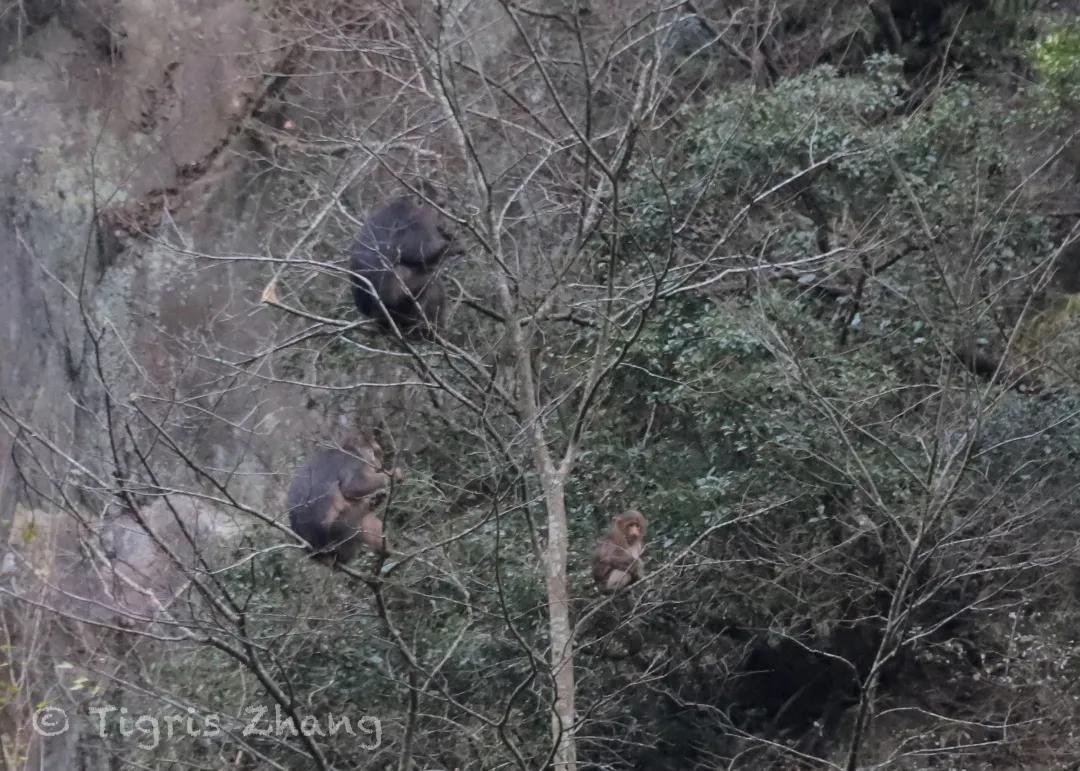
0;0;302;768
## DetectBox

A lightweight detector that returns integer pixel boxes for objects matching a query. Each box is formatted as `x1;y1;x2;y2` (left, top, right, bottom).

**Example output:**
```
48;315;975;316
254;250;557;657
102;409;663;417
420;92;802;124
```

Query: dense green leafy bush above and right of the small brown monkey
588;295;899;541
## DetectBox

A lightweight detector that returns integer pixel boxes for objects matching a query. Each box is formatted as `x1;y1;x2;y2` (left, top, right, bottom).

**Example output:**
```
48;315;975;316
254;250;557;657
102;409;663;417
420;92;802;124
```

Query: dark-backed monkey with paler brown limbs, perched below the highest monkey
288;439;405;564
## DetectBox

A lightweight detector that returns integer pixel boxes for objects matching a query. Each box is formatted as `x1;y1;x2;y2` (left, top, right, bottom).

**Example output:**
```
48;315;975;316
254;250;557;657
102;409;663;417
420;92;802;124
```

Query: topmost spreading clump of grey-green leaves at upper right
627;56;1036;275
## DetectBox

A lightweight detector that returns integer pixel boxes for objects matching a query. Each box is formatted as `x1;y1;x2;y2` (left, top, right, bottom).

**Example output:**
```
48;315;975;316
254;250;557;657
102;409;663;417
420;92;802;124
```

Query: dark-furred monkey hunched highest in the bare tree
349;186;461;336
